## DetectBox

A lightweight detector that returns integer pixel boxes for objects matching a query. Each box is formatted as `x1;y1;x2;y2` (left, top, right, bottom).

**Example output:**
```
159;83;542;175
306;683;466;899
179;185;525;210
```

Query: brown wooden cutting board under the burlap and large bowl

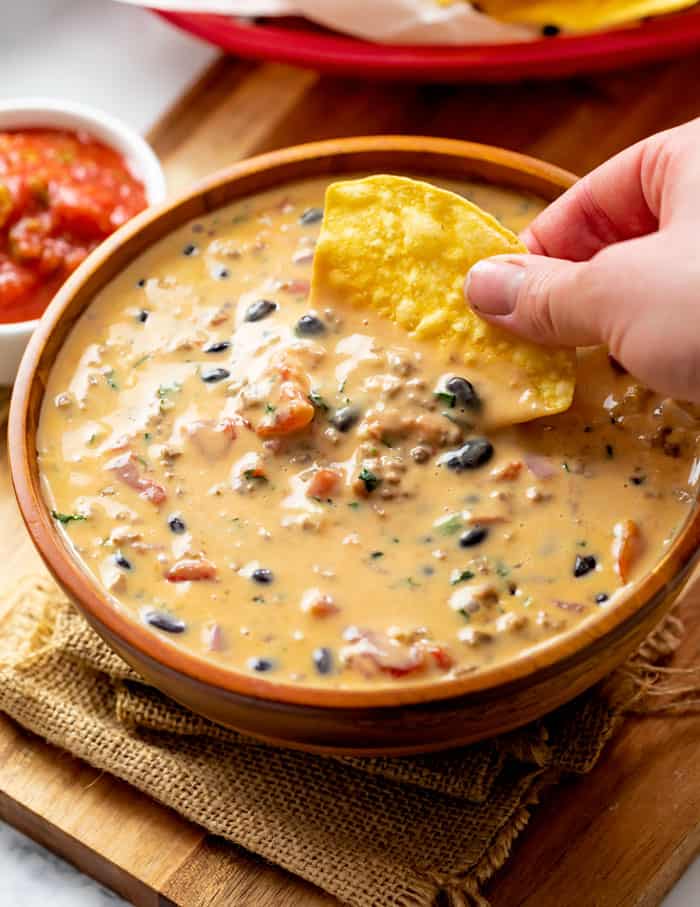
0;56;700;907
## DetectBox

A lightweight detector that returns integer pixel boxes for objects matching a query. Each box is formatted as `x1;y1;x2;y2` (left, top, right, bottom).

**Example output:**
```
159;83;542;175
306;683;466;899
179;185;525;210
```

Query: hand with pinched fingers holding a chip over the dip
465;119;700;403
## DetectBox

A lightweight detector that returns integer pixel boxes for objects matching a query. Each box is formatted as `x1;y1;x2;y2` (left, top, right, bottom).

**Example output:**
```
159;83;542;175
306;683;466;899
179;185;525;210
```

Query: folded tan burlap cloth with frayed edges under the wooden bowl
0;577;682;907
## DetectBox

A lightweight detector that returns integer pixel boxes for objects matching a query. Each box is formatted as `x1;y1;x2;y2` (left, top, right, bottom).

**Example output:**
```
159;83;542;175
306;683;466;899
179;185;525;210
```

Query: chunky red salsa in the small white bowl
0;129;146;323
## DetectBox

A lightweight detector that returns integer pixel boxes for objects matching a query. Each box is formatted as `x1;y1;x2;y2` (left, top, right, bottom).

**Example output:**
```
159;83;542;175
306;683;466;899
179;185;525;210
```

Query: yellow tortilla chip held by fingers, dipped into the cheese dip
311;176;575;422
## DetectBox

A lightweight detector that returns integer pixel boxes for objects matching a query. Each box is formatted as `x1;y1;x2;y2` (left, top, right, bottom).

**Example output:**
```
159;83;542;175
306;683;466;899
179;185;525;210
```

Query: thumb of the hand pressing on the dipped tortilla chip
464;255;613;346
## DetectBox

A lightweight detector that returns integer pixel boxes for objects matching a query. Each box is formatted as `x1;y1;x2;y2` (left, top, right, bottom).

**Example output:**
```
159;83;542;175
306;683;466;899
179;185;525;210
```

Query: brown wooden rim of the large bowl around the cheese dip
8;136;700;710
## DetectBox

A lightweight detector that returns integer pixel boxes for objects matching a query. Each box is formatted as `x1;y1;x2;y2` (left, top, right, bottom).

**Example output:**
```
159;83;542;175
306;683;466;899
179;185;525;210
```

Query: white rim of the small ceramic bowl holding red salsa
0;95;167;339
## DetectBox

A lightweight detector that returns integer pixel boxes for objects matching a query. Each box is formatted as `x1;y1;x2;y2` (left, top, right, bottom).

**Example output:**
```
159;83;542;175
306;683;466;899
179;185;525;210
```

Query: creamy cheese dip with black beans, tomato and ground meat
38;180;697;688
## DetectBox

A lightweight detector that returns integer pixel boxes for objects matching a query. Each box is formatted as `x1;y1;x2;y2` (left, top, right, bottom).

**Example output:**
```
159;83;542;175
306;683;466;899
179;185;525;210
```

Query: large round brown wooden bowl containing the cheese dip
9;137;700;755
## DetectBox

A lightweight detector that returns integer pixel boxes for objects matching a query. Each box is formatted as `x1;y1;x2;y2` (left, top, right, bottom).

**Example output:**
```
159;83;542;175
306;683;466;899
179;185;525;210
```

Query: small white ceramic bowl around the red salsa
0;98;166;385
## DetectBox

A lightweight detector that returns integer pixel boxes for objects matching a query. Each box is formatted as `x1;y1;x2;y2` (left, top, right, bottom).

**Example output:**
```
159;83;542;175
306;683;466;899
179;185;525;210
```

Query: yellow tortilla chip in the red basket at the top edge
479;0;697;32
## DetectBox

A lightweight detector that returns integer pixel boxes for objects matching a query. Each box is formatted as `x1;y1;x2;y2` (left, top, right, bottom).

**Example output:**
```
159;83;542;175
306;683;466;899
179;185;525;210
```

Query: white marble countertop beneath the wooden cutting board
0;0;700;907
